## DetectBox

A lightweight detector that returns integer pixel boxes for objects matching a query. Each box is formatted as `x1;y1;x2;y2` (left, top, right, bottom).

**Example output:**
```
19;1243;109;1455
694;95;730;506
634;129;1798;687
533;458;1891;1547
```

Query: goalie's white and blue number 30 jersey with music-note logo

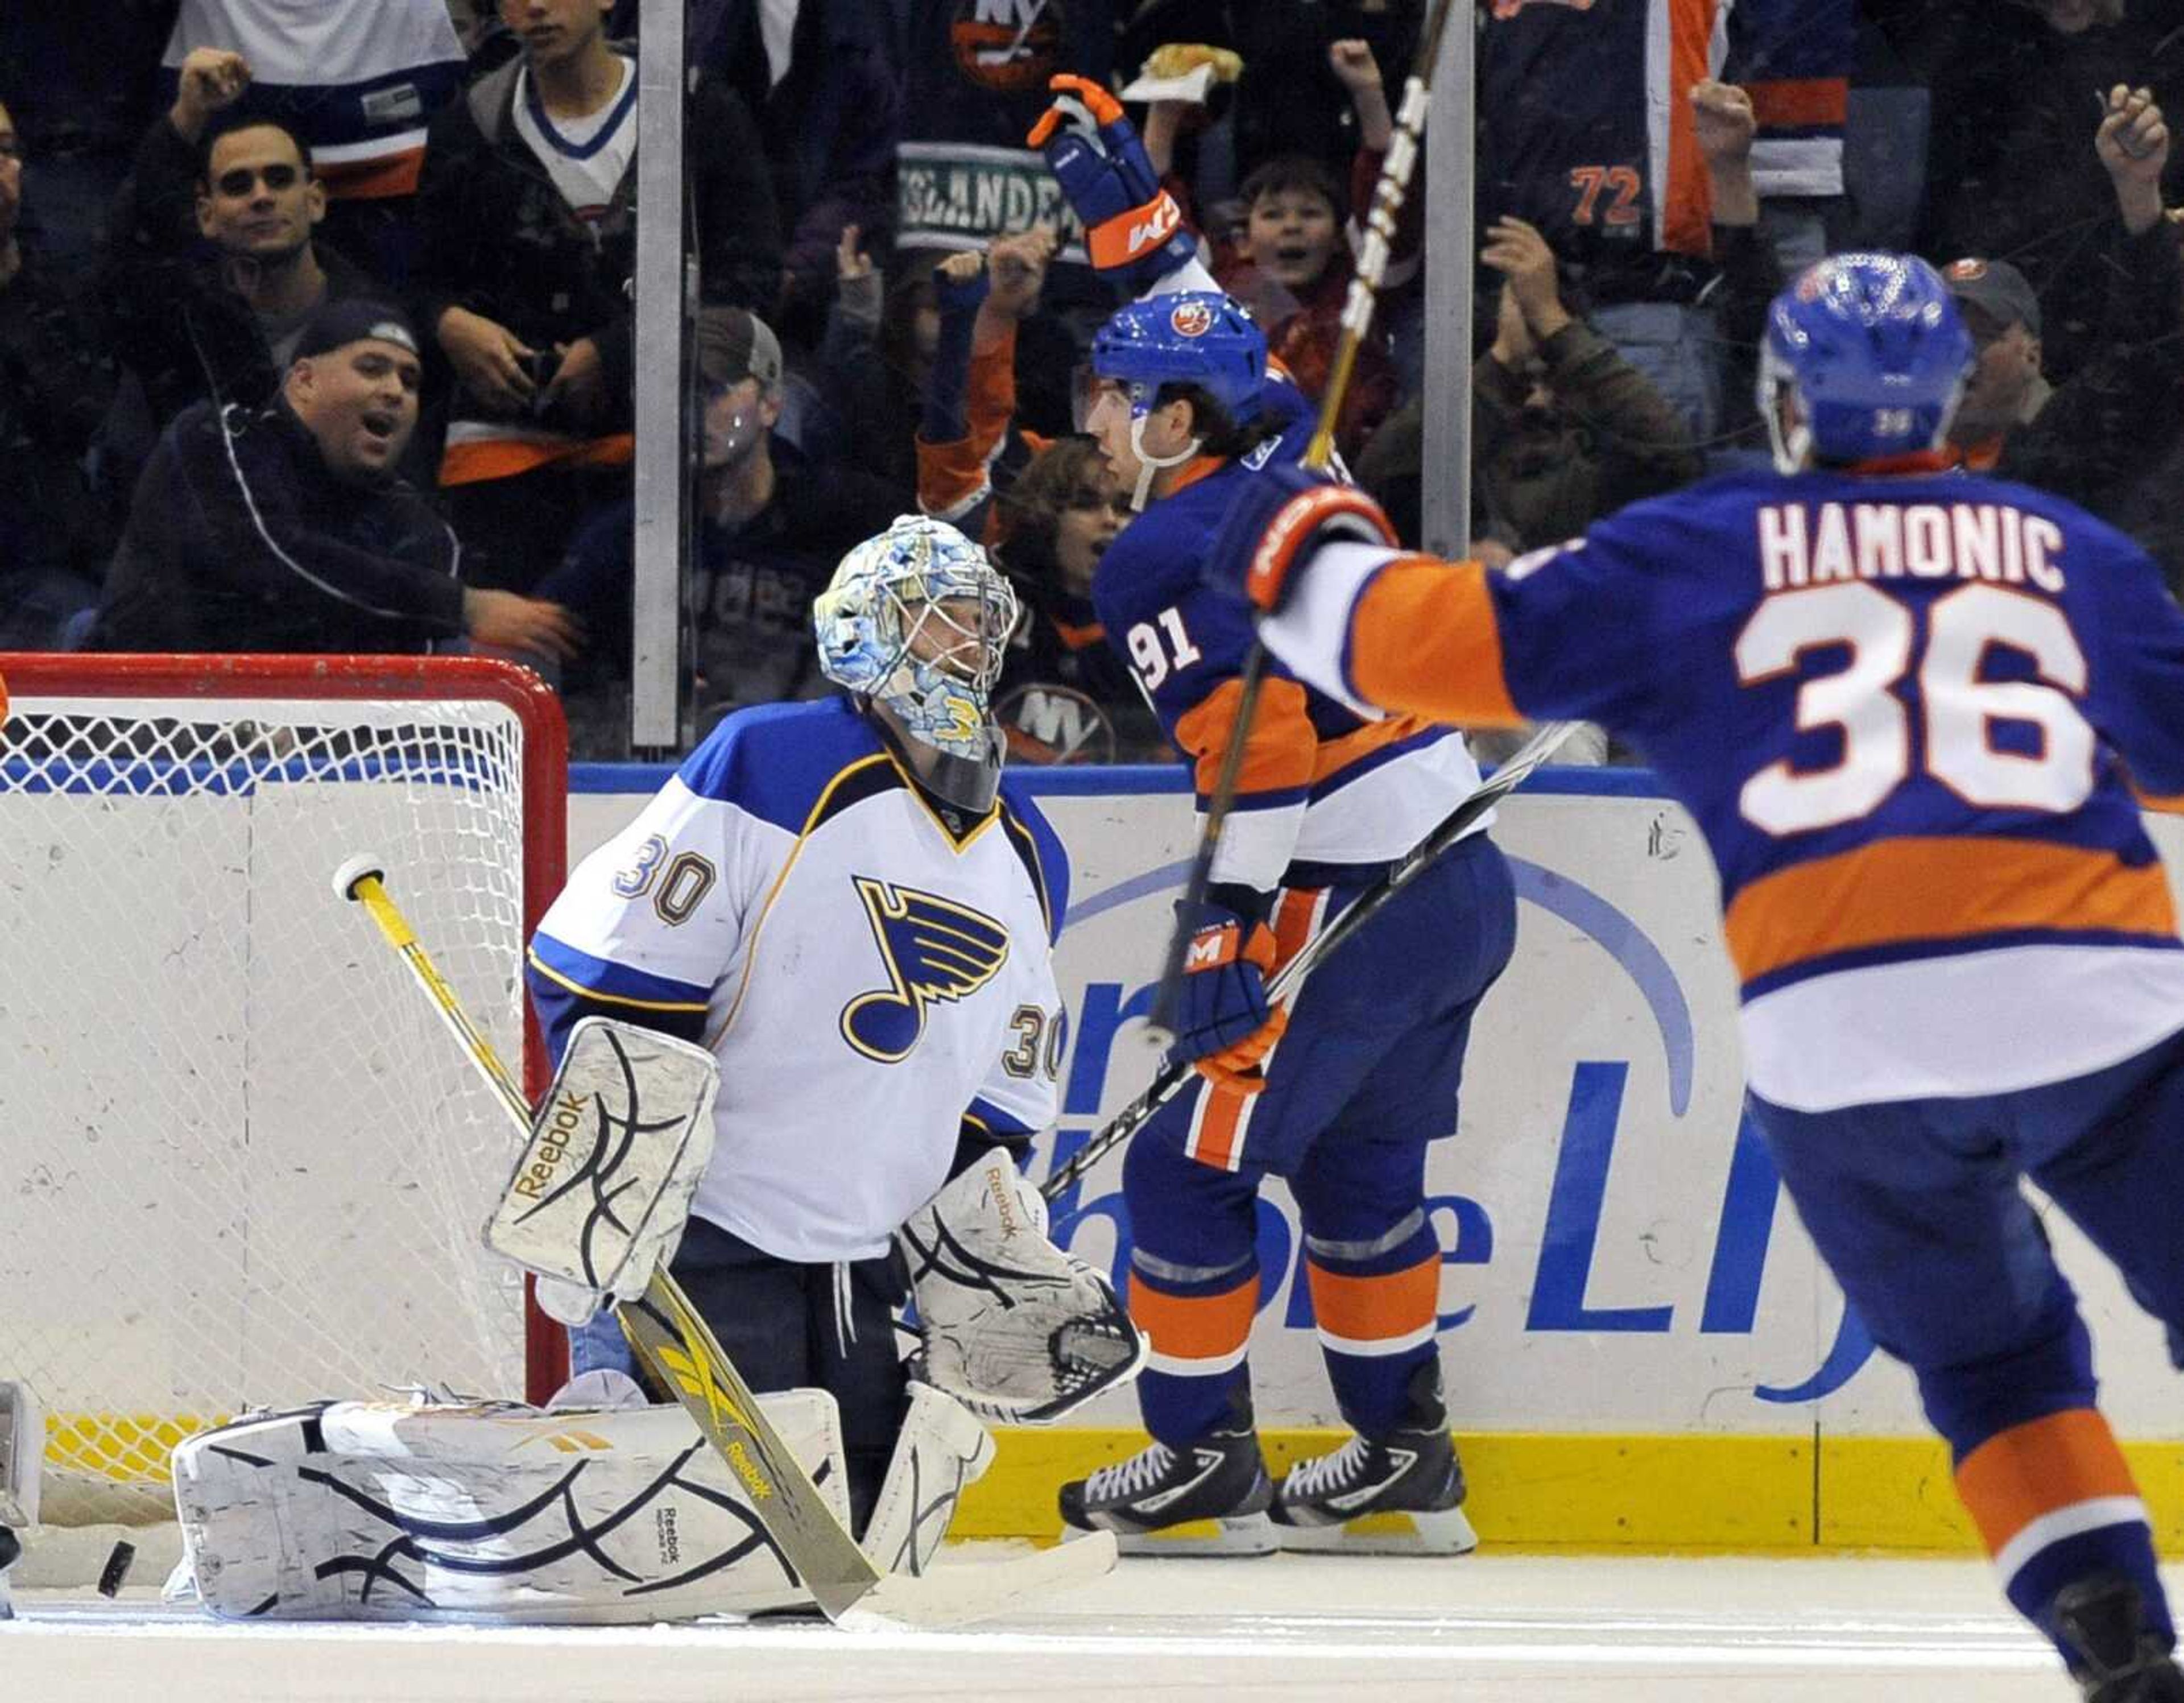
531;698;1068;1262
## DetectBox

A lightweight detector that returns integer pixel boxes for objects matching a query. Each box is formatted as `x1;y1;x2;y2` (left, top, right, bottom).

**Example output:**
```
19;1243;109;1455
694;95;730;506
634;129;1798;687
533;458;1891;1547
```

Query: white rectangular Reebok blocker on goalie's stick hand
485;1018;721;1325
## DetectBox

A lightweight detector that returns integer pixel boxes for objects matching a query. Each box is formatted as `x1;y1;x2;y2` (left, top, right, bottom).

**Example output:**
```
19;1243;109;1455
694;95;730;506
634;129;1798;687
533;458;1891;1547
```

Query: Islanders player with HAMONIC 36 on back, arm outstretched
1208;255;2184;1703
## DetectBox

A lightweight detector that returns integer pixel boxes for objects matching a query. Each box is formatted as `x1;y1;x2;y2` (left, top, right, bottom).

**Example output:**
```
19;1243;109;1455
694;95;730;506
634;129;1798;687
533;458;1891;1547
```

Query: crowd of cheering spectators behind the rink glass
0;0;2184;762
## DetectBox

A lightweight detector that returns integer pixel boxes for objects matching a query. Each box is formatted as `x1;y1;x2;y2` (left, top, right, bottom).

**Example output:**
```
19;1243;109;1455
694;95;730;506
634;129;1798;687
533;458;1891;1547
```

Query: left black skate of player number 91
1061;1398;1280;1555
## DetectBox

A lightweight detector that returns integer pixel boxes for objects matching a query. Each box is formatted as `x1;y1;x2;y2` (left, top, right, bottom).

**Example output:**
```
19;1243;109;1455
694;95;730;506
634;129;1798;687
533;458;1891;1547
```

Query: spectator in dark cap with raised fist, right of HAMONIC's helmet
1942;85;2184;520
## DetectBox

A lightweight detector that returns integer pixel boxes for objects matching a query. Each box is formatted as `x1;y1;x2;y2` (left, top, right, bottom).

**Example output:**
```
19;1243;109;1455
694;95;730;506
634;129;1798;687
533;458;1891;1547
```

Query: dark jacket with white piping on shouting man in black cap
89;402;463;653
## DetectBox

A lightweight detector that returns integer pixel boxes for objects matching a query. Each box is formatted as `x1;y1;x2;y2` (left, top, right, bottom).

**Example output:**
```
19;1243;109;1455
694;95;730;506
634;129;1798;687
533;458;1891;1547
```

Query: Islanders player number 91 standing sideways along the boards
1061;291;1516;1552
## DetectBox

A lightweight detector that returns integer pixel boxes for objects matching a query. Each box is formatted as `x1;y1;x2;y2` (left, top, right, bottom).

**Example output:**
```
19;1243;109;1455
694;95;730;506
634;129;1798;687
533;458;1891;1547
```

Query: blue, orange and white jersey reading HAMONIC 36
1267;472;2184;1111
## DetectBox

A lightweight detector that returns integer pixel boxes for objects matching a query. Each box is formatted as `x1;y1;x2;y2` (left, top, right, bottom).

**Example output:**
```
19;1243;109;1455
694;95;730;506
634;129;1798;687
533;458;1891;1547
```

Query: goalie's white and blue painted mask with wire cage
812;515;1017;812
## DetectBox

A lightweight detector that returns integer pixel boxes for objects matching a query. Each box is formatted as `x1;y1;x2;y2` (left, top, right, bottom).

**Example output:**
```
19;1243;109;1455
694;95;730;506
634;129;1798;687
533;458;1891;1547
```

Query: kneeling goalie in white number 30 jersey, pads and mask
175;518;1144;1622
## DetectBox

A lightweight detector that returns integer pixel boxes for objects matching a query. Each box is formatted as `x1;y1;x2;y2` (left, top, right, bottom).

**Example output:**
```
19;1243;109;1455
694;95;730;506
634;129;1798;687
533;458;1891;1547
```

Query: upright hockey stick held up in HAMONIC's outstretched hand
1153;0;1454;1028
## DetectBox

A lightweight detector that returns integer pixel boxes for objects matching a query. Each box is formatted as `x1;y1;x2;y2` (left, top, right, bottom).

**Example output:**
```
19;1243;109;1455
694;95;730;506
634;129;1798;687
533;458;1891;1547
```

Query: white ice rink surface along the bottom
0;1550;2149;1703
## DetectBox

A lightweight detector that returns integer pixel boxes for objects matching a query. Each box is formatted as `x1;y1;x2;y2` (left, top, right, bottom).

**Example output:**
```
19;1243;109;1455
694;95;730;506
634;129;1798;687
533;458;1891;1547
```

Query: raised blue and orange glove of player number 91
1024;76;1199;295
